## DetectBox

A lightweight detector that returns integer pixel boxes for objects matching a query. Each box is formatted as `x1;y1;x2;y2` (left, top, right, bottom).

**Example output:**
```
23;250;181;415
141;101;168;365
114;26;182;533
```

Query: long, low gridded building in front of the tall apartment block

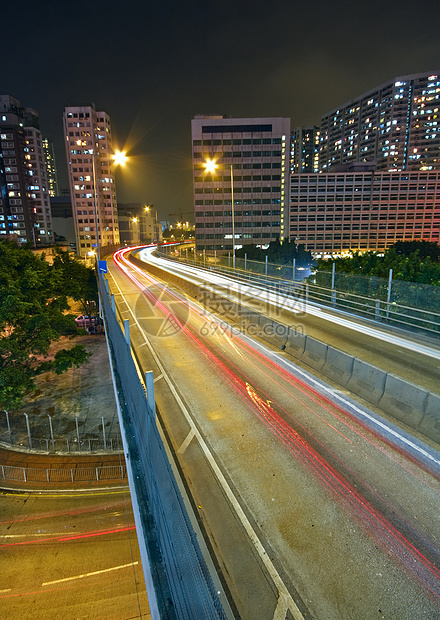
290;163;440;257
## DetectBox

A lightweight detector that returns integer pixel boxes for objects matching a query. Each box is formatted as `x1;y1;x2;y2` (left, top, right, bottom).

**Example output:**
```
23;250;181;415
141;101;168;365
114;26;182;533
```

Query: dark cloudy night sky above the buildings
0;0;440;220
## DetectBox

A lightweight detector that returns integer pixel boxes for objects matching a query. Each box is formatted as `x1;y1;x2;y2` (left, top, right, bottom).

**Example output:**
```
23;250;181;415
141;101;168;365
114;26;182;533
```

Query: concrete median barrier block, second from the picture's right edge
378;374;428;428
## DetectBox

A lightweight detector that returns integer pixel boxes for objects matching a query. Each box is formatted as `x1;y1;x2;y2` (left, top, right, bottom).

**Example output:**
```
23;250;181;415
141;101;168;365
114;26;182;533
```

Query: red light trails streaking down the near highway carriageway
114;250;440;599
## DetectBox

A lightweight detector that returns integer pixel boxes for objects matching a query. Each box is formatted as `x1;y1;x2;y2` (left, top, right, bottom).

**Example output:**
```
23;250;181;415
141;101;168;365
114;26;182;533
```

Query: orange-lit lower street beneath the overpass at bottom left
0;488;151;620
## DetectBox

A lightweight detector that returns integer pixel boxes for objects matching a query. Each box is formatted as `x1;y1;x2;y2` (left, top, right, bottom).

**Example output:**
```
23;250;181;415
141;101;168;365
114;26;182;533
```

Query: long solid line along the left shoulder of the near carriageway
110;271;304;620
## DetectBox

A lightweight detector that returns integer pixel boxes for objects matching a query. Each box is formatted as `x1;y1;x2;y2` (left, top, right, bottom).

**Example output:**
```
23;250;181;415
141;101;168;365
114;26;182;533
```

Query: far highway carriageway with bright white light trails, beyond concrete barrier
139;248;440;393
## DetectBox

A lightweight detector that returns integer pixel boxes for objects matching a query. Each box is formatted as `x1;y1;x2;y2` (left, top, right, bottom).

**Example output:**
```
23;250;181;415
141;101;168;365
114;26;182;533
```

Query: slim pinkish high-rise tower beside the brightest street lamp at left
63;106;119;257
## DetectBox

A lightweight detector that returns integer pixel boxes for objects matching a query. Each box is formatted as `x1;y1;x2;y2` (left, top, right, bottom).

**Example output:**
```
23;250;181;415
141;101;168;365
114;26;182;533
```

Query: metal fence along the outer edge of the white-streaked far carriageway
159;247;440;337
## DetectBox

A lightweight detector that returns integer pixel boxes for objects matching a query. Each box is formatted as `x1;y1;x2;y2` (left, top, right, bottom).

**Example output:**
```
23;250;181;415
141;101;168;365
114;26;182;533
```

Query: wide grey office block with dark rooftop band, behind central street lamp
191;115;290;252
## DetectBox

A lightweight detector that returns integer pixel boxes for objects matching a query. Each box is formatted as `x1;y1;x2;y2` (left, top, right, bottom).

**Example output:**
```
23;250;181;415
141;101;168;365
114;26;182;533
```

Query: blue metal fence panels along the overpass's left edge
100;279;227;620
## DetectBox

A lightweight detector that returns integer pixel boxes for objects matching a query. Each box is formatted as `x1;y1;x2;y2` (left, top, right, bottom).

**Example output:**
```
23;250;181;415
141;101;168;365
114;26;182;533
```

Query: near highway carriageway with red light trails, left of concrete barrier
108;249;440;620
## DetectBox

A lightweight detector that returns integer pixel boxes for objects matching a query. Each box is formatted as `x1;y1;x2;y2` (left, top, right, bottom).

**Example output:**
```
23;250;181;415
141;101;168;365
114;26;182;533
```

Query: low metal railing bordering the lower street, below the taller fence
0;465;127;484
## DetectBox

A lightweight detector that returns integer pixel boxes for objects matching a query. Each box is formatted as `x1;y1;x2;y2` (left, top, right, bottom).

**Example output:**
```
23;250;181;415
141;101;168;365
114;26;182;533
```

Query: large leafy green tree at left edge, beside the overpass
0;239;89;409
